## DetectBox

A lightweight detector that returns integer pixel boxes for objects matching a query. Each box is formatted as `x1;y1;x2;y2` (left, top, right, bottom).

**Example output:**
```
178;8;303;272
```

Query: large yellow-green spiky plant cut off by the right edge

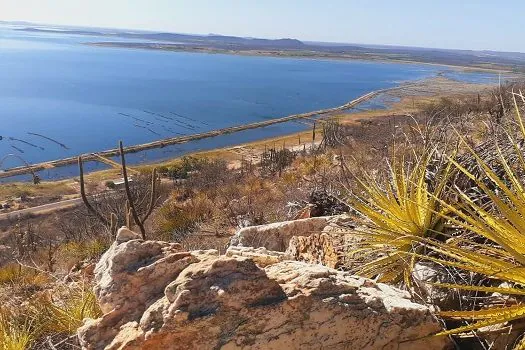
404;94;525;340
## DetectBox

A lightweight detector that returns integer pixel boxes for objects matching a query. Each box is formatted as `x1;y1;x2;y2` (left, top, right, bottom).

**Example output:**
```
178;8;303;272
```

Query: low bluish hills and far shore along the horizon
0;21;525;72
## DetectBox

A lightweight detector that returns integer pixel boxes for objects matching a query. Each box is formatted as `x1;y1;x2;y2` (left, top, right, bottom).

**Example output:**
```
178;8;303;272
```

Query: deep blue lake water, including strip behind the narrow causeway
0;27;496;177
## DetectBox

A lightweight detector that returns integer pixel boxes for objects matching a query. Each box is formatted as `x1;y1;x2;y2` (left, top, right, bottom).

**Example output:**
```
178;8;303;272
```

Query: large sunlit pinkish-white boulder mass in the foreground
79;230;449;350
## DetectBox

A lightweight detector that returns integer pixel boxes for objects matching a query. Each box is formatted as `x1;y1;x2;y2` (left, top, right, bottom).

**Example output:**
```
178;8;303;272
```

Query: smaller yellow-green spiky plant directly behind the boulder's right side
350;152;450;283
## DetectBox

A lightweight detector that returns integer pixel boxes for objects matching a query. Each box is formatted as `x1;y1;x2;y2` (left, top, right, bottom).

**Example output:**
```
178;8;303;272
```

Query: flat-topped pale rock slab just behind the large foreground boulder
230;216;350;252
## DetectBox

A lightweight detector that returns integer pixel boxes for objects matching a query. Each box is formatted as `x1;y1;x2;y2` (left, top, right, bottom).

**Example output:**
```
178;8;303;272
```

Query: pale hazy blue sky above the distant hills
0;0;525;51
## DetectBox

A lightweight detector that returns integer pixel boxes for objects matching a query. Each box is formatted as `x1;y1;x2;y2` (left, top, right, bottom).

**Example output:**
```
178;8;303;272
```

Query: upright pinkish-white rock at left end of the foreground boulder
77;240;191;349
